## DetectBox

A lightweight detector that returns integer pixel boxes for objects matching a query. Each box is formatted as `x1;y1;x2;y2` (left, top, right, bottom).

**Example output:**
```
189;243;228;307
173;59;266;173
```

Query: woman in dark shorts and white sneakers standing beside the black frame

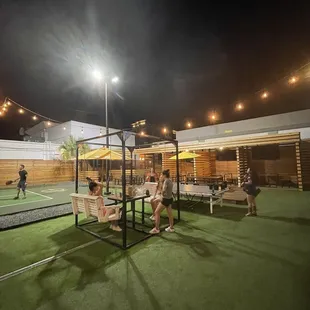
150;170;174;234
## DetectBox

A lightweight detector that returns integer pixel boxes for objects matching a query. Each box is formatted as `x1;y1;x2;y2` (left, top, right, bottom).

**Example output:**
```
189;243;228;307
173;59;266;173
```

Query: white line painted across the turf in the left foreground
0;239;101;282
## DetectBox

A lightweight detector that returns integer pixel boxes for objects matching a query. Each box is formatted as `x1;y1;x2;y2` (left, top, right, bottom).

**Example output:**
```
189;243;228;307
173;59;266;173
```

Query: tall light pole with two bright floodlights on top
93;70;119;195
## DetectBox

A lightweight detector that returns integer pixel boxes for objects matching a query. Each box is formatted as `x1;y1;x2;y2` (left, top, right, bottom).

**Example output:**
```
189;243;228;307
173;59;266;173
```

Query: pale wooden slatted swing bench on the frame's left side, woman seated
70;193;121;223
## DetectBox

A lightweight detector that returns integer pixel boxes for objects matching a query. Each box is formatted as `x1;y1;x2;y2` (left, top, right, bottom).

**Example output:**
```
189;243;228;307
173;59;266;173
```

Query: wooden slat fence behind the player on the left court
0;159;74;185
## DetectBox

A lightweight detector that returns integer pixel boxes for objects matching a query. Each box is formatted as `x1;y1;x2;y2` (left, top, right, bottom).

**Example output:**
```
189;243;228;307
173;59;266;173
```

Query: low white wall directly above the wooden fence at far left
0;140;60;160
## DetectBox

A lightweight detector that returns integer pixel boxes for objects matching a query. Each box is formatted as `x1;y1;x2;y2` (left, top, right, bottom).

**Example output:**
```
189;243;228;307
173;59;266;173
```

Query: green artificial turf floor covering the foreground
0;190;310;310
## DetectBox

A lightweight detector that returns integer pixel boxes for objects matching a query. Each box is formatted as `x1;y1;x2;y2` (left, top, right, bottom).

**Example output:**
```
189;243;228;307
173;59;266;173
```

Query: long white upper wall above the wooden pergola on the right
176;109;310;142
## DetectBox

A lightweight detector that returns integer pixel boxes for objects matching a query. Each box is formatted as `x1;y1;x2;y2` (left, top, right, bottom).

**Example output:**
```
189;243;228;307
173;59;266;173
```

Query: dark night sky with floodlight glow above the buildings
0;0;310;138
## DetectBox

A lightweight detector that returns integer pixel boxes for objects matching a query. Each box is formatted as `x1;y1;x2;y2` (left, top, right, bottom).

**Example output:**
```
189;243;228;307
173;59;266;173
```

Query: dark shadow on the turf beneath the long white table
174;200;247;222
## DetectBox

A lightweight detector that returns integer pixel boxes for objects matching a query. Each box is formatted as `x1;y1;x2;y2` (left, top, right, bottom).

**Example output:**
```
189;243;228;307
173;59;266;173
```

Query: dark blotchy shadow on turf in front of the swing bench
36;226;124;309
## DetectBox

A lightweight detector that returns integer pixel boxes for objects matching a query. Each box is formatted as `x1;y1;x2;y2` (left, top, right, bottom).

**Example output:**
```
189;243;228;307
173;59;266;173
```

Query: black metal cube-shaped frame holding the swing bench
75;130;181;250
